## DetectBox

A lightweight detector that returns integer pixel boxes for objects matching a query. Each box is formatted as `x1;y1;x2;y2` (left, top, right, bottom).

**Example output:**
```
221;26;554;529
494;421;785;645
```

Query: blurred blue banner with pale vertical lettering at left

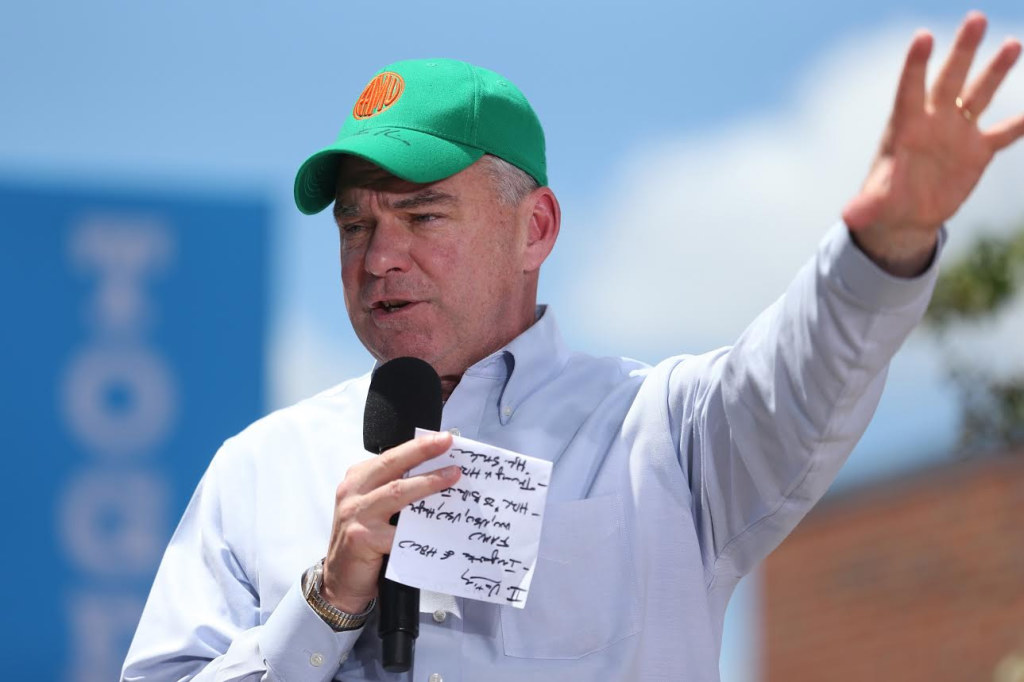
0;184;269;682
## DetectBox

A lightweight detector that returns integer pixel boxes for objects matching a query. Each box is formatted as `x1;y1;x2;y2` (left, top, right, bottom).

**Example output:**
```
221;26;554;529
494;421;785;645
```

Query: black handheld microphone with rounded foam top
362;357;441;673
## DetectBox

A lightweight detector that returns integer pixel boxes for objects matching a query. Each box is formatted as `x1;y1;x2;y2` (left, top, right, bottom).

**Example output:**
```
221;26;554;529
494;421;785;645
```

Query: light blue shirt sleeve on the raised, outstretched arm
670;223;945;580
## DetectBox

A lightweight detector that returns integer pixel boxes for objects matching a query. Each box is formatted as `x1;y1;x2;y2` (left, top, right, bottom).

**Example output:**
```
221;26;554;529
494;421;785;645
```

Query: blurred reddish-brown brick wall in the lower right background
762;452;1024;682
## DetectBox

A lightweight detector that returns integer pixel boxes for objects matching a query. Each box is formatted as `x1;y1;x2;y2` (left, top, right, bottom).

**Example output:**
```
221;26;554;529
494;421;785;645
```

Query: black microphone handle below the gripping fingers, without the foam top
377;507;420;673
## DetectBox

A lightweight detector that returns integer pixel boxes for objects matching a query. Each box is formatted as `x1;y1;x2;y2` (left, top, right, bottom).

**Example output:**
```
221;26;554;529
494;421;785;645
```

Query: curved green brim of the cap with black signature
295;128;483;215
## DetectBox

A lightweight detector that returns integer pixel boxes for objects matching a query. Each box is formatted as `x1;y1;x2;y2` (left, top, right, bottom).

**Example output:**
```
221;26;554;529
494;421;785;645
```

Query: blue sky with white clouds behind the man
0;0;1024;680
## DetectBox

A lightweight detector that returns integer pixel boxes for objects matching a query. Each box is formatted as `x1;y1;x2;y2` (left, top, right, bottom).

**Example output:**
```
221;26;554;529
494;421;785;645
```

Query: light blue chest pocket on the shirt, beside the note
500;495;640;658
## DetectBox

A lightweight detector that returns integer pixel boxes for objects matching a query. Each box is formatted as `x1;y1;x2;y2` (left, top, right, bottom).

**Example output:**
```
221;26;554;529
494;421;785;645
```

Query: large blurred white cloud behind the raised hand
569;21;1024;356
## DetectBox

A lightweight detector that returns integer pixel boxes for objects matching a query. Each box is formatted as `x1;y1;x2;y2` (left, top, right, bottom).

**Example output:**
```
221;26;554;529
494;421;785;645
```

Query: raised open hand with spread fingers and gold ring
843;12;1024;276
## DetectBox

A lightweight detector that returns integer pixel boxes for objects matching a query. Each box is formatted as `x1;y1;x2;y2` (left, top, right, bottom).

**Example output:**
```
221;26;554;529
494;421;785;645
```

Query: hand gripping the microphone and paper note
322;433;460;613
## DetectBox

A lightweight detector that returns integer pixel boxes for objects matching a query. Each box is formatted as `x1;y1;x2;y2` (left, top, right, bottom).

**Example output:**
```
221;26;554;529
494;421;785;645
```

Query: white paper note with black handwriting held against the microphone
387;429;551;608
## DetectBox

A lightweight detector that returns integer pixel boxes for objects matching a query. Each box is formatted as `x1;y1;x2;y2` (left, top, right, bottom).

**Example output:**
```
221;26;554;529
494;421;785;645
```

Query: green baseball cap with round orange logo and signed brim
295;59;548;215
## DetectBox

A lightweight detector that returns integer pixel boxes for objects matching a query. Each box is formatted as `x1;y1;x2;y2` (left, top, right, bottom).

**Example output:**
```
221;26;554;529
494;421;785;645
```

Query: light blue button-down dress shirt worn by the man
123;220;935;682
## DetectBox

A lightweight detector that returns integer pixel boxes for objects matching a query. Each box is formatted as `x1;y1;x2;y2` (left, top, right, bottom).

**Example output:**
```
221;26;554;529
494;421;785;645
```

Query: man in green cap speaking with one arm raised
123;14;1024;682
